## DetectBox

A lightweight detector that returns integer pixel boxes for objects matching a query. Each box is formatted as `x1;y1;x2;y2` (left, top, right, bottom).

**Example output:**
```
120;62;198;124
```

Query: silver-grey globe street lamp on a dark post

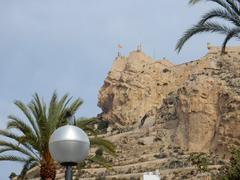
49;125;90;180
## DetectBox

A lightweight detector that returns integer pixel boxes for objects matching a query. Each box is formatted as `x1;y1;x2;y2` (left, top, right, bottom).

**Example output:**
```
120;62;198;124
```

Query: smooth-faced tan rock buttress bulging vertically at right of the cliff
175;75;220;152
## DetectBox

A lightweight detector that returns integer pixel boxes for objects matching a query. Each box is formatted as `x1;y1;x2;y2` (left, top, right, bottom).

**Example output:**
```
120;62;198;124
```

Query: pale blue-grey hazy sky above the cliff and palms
0;0;238;180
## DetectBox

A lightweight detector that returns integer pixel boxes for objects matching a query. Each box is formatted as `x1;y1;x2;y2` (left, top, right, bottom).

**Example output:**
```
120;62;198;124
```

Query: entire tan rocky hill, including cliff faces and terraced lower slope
17;46;240;180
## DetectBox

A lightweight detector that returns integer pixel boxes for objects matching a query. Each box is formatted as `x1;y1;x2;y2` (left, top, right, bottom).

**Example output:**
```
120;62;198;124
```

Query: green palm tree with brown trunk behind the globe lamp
0;93;115;180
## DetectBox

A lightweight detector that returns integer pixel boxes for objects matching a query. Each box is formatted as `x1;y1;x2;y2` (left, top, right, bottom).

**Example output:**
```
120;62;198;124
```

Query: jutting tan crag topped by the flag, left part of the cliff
98;51;214;126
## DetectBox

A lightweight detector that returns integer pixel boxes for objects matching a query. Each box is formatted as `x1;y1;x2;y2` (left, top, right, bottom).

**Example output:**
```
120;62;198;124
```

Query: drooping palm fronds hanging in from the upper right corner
176;0;240;53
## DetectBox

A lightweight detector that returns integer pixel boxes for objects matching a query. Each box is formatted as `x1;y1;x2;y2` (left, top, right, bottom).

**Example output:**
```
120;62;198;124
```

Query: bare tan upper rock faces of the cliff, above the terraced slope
98;46;240;153
